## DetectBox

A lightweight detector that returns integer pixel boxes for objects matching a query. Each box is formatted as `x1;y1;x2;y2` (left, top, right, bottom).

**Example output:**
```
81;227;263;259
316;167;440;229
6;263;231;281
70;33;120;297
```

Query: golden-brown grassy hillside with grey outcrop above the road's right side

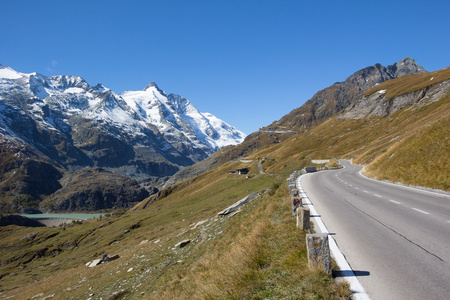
239;68;450;191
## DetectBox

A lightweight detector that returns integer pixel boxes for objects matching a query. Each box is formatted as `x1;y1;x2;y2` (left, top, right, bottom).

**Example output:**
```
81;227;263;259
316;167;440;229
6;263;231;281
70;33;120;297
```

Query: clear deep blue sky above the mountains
0;0;450;134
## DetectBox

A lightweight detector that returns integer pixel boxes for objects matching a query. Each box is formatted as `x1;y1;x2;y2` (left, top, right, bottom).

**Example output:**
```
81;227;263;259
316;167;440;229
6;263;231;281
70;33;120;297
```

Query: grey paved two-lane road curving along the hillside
301;161;450;300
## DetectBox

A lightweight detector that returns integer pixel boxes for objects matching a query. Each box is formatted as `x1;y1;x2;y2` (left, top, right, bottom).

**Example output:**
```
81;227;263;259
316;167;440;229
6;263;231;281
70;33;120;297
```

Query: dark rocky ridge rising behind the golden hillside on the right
165;57;426;187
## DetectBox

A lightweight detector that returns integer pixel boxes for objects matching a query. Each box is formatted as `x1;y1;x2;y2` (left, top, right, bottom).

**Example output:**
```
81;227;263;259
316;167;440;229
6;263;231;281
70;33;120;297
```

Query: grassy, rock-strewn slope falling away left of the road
0;160;349;299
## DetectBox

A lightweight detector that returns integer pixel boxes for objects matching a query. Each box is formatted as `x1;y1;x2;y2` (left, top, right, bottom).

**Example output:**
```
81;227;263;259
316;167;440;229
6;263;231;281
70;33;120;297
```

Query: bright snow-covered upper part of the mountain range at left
0;65;245;154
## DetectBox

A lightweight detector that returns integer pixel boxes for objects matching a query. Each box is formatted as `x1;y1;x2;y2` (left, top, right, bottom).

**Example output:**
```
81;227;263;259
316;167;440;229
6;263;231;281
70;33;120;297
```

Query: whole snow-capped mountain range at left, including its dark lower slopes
0;65;245;212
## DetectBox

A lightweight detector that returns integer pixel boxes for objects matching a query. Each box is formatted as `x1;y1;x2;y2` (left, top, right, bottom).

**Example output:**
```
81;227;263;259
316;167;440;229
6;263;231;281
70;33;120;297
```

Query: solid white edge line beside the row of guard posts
296;175;370;300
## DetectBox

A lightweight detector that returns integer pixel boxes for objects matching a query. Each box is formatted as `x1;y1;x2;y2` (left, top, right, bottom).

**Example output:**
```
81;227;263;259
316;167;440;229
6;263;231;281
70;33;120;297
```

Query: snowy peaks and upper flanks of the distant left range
0;66;245;170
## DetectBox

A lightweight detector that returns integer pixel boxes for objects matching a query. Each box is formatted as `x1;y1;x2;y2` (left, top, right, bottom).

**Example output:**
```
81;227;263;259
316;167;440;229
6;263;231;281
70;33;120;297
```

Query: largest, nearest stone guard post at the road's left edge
306;233;331;275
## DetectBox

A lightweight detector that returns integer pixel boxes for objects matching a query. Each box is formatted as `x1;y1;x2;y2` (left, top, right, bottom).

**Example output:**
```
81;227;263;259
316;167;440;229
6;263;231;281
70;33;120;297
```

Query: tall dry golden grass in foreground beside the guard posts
155;185;350;299
